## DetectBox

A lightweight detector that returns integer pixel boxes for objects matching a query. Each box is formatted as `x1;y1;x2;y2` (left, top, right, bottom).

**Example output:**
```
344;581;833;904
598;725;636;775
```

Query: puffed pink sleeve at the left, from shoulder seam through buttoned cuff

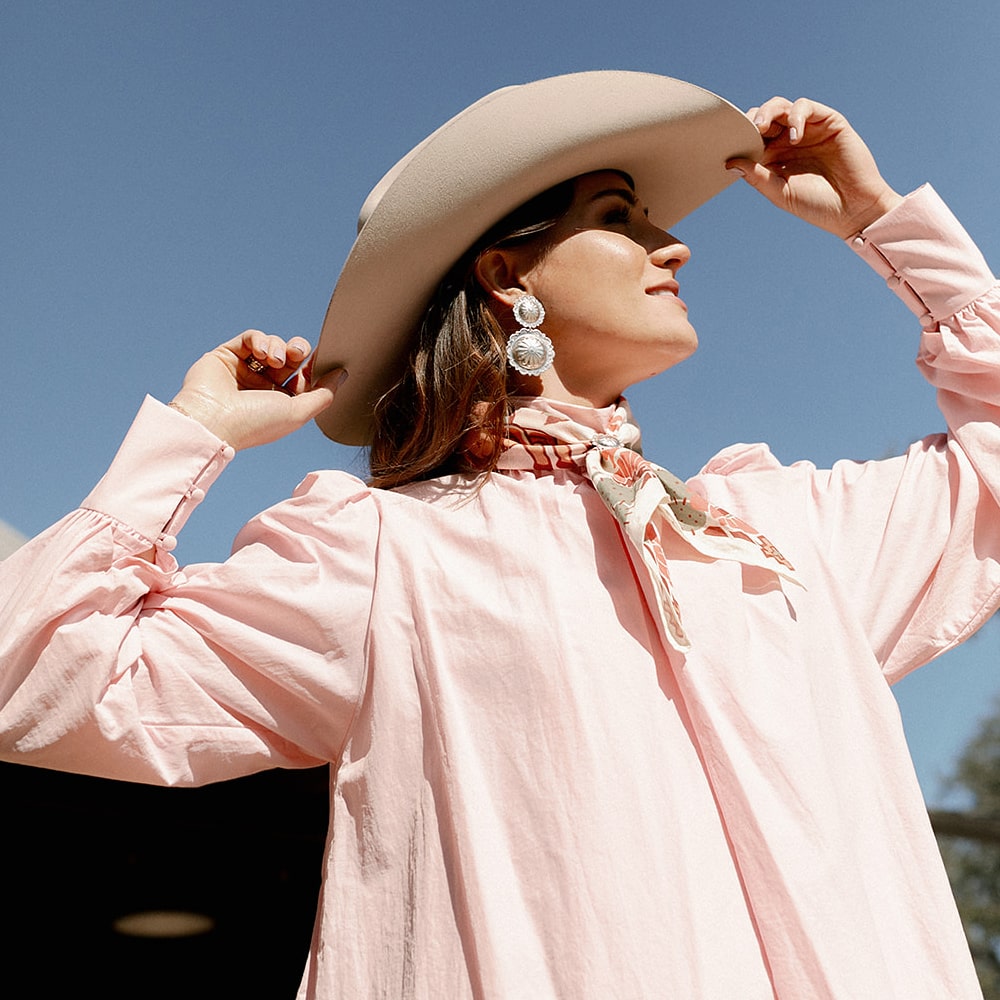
0;400;379;784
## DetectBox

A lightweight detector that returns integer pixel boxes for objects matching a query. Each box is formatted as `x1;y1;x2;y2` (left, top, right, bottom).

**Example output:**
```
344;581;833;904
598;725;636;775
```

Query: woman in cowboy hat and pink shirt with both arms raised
0;73;1000;1000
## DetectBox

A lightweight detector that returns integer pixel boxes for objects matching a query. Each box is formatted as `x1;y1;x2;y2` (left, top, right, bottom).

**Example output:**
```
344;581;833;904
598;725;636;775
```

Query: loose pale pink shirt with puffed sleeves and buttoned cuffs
0;188;1000;1000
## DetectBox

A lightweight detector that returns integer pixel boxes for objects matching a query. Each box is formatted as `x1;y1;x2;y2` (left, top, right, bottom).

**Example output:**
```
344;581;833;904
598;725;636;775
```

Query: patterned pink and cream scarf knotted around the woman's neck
498;397;798;652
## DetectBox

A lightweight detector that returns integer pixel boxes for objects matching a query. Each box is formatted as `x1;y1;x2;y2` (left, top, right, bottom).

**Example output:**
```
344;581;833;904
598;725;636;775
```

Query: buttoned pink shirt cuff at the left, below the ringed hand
81;396;236;551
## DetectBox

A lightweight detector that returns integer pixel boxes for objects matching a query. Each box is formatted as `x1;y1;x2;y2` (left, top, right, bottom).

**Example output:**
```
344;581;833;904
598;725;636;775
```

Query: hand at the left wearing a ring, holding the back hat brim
170;330;347;451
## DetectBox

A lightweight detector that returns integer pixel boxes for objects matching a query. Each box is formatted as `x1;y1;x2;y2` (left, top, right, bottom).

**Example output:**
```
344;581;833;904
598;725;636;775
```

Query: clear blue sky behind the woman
0;0;1000;802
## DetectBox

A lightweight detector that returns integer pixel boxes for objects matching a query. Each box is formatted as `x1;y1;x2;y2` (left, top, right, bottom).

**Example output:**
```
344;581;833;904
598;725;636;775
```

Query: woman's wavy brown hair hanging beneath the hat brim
369;180;574;489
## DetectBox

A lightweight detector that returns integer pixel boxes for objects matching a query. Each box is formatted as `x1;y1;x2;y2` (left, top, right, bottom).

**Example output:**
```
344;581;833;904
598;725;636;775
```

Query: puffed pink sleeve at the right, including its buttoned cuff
796;186;1000;679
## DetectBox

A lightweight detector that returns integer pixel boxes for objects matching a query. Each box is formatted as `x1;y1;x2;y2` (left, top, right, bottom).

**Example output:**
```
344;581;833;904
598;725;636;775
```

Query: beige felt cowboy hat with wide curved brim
313;71;763;444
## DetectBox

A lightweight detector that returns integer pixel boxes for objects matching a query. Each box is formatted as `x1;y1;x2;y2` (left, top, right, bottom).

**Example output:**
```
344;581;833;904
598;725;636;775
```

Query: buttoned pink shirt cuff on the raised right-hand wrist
847;184;996;329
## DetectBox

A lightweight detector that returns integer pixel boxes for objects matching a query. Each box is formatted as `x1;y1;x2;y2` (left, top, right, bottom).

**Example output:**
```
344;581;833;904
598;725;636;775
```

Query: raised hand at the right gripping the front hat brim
726;97;902;239
